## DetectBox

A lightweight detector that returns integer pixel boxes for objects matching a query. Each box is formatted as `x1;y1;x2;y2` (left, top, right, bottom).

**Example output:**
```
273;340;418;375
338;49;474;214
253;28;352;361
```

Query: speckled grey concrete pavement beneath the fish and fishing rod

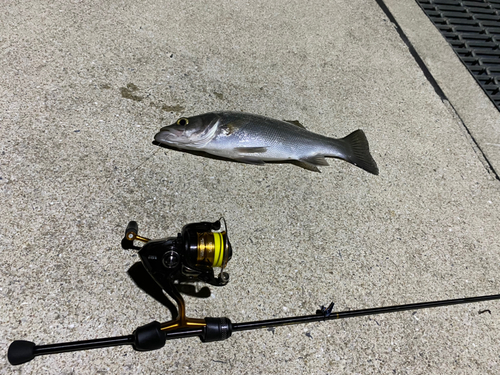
0;0;500;374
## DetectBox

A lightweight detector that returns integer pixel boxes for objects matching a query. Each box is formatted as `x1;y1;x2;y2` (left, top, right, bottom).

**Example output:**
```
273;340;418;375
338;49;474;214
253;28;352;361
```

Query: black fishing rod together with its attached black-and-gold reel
8;219;500;365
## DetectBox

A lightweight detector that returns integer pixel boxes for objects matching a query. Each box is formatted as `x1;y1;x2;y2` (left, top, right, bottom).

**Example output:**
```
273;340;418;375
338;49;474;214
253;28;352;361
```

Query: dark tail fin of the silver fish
341;129;378;175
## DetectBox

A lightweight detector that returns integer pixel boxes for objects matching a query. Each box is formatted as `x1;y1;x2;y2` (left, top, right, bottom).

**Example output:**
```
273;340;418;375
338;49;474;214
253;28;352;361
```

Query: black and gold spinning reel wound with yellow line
122;219;233;336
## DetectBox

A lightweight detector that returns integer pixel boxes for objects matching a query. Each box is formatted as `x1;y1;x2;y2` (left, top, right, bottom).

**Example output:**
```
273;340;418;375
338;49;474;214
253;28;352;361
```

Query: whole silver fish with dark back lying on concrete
153;111;379;175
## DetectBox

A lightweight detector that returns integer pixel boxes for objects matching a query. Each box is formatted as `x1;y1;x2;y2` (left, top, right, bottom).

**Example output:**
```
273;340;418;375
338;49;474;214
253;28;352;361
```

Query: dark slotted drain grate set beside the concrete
416;0;500;110
